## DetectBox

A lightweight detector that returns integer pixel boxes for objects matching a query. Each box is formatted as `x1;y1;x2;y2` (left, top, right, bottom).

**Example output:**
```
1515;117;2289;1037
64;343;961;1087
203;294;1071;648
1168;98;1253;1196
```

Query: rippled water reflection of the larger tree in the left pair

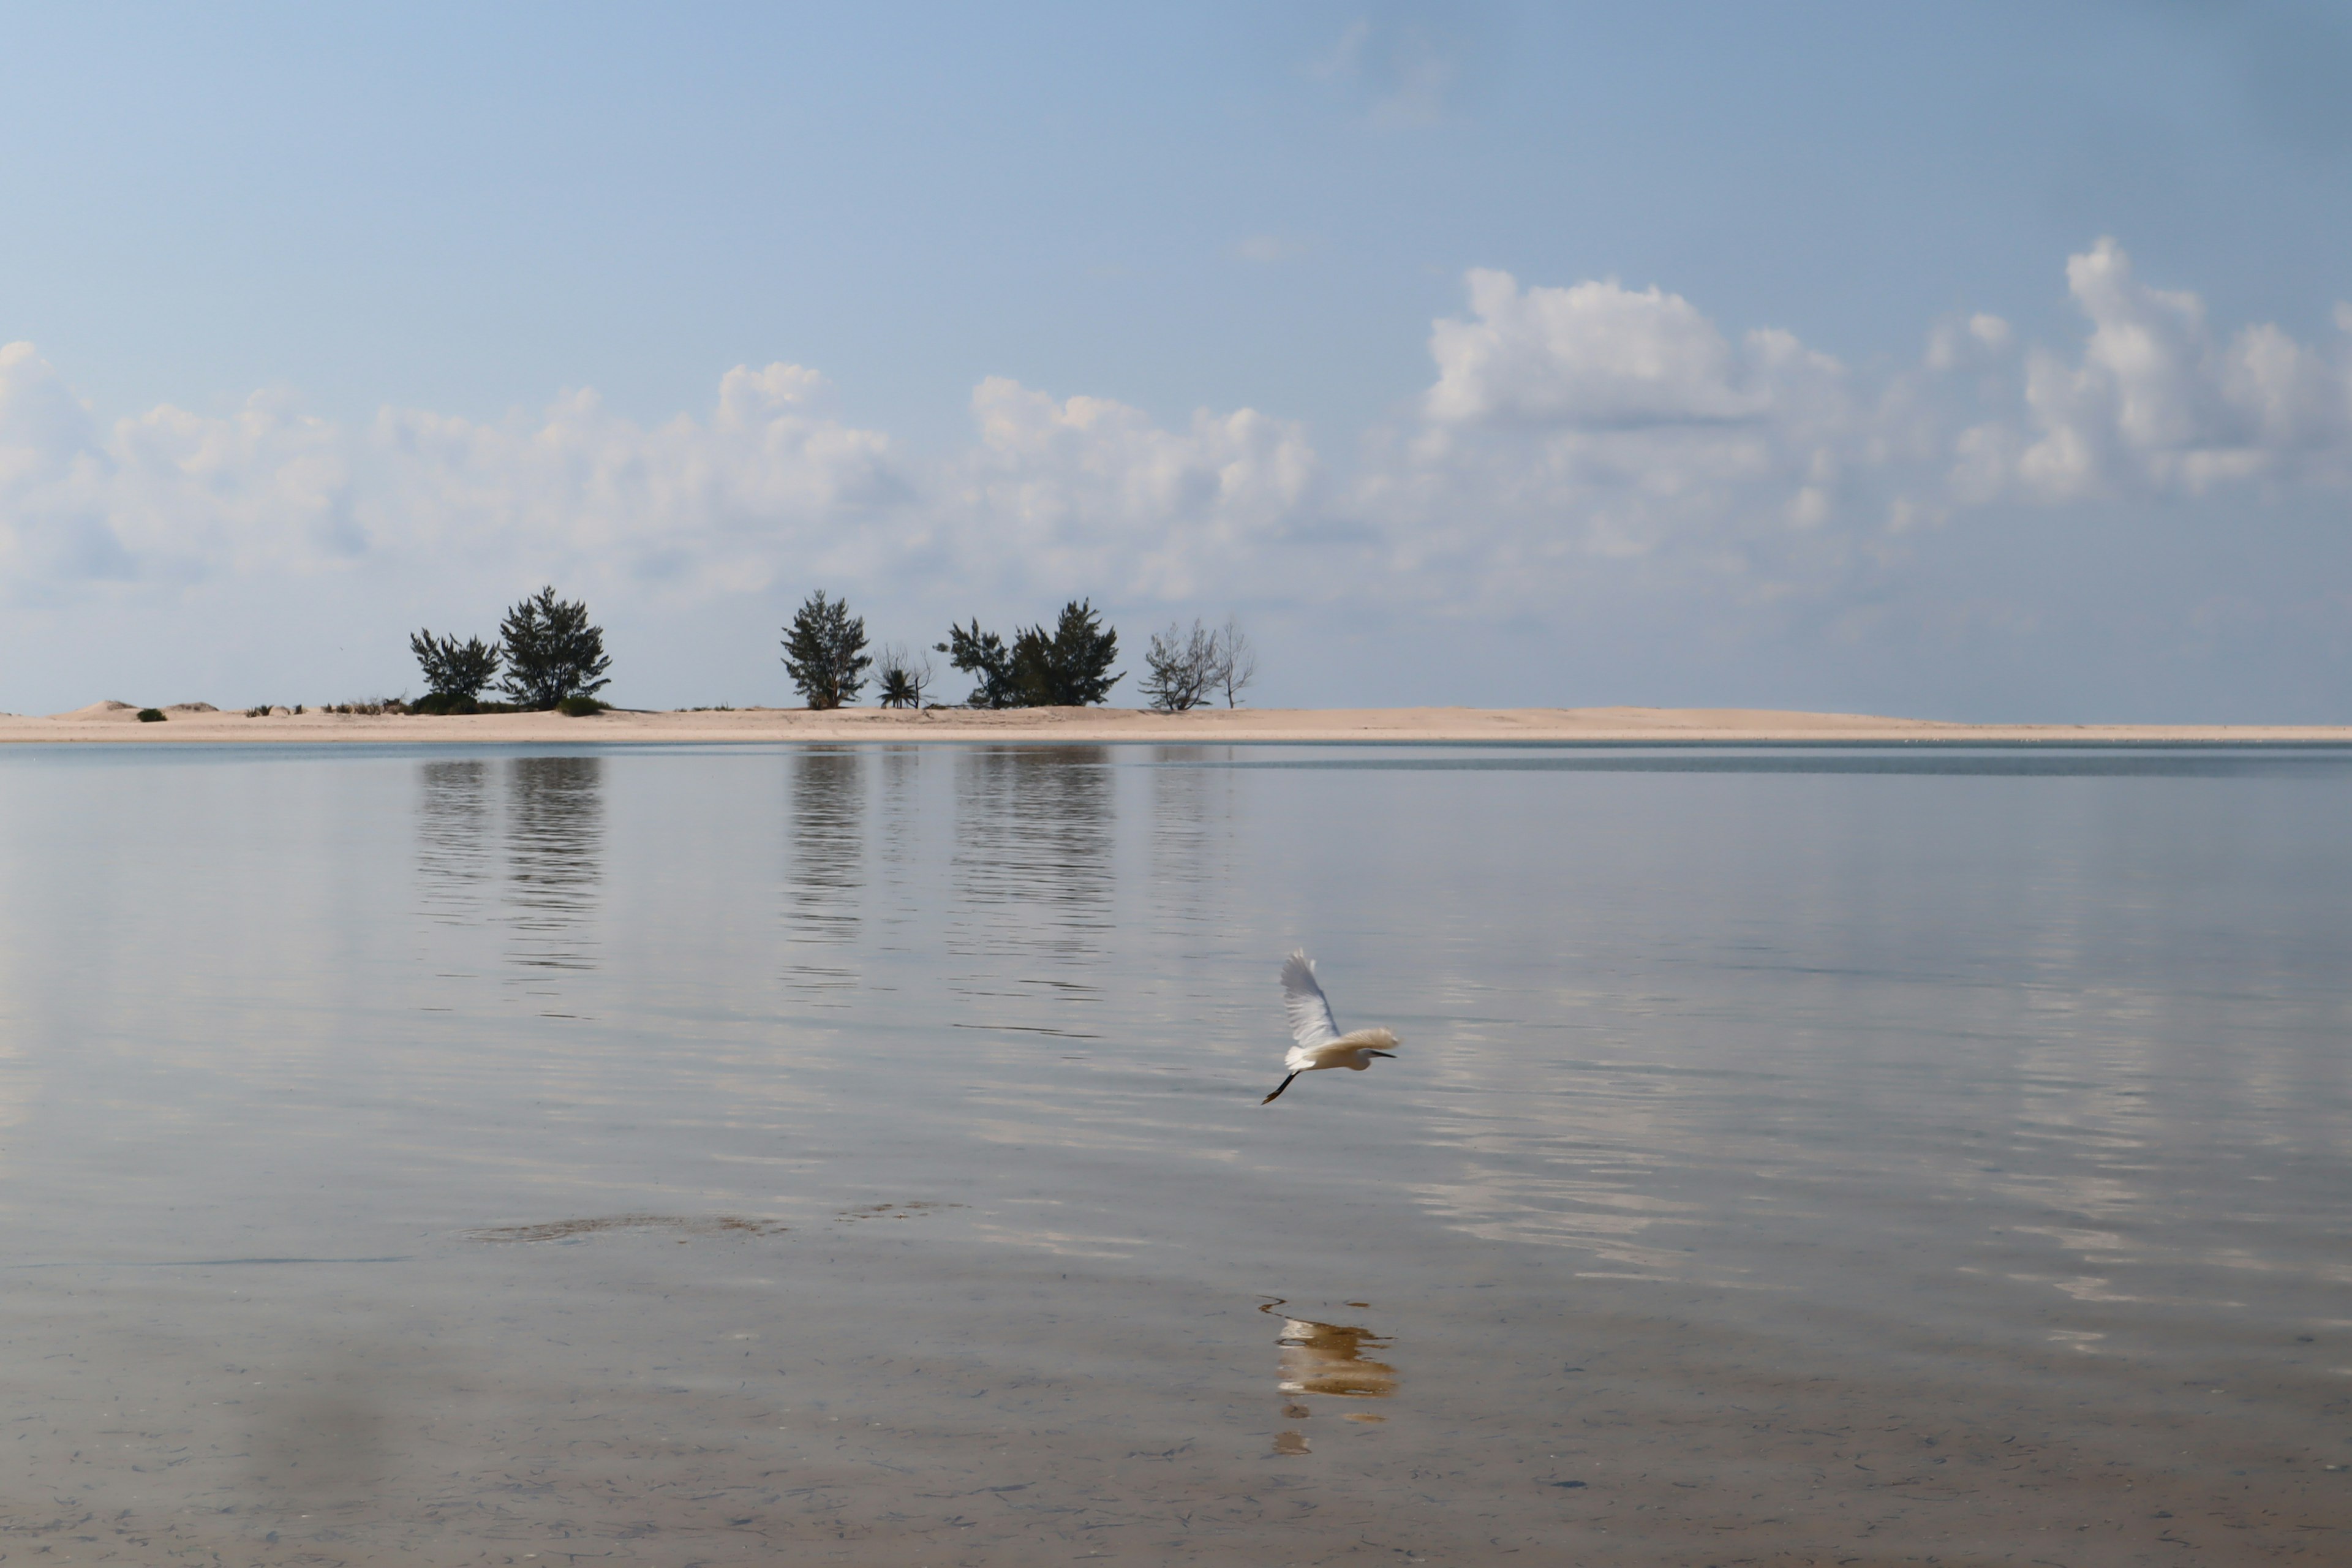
506;757;605;968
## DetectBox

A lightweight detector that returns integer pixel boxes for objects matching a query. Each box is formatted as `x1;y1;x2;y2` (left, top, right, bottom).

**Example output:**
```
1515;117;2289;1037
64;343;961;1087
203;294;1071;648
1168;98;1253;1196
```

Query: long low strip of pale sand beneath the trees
0;703;2352;745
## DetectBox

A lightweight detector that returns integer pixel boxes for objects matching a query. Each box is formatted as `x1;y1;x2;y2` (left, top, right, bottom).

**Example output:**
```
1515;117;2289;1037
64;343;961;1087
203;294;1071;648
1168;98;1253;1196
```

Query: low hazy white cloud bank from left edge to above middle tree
0;355;922;597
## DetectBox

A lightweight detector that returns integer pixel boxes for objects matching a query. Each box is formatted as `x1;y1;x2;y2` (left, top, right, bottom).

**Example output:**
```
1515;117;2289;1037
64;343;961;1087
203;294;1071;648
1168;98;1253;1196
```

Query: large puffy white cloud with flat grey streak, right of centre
1355;270;1868;604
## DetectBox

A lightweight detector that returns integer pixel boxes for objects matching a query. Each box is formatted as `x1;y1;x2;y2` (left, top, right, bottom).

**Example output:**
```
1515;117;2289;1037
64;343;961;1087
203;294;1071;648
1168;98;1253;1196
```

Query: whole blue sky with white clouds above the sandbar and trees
0;0;2352;722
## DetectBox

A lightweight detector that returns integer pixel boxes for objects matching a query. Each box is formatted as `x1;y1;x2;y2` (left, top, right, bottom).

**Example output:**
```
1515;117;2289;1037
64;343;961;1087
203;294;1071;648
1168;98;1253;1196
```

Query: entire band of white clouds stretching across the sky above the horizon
0;239;2352;701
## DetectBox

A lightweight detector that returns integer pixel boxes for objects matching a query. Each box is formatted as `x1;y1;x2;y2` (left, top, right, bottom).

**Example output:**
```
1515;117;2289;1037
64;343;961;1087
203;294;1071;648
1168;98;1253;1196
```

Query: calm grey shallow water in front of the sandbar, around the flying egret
0;748;2352;1568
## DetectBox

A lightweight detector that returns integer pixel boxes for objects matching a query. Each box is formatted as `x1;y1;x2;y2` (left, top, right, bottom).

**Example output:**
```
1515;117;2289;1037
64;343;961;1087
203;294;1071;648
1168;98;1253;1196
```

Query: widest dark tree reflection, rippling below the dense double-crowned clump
950;745;1115;962
